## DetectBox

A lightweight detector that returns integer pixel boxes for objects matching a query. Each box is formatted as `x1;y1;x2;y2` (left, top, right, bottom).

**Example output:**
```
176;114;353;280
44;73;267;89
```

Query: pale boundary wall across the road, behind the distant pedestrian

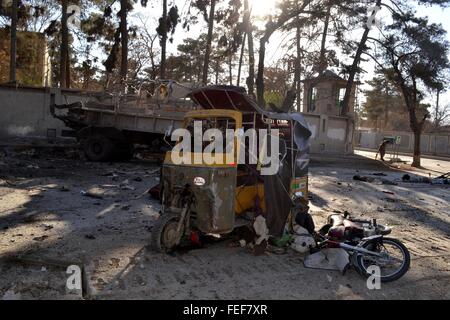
354;130;450;157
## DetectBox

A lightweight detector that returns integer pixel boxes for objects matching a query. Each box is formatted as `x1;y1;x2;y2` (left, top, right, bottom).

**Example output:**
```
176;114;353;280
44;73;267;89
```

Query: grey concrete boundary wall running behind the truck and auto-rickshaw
0;86;353;154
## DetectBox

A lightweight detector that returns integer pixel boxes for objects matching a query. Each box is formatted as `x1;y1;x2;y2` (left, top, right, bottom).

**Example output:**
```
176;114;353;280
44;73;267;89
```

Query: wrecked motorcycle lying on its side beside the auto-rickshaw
296;195;411;282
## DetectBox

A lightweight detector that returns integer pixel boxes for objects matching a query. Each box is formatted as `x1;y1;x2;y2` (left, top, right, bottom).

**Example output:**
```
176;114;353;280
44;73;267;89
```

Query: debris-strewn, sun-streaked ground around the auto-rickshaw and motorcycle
0;145;450;299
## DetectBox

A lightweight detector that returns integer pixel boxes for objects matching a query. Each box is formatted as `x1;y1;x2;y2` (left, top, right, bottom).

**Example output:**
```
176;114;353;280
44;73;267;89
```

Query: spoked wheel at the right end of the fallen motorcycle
356;238;411;282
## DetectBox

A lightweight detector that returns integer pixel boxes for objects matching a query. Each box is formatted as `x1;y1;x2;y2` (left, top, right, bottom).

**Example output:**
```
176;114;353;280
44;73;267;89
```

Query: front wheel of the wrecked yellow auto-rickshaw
150;213;184;253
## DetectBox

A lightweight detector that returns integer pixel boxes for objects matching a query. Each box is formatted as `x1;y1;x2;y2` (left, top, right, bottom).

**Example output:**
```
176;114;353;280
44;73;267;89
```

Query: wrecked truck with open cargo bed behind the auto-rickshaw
50;81;197;162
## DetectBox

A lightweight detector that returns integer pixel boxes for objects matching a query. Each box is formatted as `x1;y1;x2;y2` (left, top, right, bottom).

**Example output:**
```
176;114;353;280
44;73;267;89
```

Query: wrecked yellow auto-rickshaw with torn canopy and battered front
151;86;311;252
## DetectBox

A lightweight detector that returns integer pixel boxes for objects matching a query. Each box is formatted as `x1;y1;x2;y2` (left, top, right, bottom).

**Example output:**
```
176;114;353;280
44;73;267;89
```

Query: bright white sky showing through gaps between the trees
135;0;450;104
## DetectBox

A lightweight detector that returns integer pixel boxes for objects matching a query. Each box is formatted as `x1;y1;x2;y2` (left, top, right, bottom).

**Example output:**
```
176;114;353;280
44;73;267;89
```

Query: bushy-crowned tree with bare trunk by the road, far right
370;11;450;167
